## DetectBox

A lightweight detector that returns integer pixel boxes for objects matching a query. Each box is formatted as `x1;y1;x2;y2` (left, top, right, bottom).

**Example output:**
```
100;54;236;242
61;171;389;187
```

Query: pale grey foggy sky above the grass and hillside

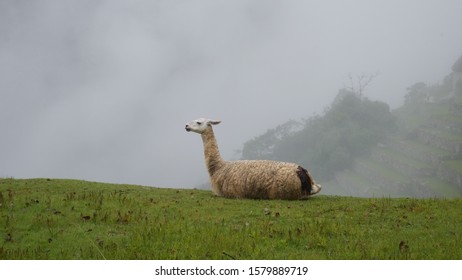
0;0;462;187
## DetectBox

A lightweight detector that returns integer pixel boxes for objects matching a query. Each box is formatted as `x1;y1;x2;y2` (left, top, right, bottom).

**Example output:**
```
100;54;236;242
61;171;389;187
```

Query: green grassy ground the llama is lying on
0;179;462;259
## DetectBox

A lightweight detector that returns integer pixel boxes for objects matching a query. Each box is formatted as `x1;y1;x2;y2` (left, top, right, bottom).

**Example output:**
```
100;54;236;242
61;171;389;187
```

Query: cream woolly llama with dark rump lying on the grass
186;118;321;199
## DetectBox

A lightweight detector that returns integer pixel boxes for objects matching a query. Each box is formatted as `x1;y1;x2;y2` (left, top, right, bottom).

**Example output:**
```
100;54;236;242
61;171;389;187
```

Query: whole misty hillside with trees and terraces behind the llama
242;76;462;198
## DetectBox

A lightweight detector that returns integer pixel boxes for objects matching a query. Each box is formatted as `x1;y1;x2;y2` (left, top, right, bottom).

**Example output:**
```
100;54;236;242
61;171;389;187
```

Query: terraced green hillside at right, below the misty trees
324;93;462;197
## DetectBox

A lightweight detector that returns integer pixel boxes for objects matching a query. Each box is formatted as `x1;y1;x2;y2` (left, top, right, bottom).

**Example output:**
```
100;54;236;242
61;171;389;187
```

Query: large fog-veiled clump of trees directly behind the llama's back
243;89;395;180
